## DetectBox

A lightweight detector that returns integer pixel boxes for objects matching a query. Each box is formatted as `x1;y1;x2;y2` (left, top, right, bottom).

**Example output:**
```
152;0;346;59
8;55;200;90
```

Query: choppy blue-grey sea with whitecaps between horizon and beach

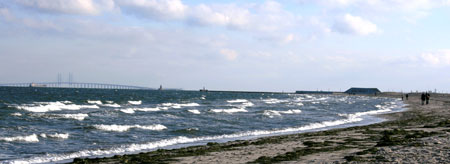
0;87;404;163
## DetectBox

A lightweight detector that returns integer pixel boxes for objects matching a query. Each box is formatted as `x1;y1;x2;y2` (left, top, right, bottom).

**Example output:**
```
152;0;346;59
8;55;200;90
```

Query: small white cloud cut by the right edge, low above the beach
421;49;450;67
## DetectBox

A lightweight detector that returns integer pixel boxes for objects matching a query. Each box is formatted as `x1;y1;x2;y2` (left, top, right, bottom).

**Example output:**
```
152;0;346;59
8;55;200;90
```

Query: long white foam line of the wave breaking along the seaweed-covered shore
7;118;361;163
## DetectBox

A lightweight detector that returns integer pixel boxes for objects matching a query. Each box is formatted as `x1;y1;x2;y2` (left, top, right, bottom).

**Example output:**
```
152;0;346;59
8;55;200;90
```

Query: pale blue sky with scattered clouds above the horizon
0;0;450;92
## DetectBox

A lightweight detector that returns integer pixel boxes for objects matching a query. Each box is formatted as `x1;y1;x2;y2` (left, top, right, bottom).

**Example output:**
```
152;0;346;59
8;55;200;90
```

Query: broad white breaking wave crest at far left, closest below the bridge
16;101;99;112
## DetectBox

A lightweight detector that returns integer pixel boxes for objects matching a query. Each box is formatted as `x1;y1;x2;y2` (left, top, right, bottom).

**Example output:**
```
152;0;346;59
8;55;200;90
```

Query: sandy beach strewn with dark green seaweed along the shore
74;93;450;164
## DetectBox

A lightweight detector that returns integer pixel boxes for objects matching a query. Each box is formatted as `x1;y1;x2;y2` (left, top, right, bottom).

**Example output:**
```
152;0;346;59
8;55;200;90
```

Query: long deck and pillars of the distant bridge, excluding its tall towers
0;82;154;90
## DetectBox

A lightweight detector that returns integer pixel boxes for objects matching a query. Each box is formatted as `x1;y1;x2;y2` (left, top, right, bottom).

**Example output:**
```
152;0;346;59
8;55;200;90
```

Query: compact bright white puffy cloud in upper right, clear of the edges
333;14;378;35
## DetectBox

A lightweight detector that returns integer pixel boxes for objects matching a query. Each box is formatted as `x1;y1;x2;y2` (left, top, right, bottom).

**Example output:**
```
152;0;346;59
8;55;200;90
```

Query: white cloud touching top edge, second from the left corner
116;0;188;20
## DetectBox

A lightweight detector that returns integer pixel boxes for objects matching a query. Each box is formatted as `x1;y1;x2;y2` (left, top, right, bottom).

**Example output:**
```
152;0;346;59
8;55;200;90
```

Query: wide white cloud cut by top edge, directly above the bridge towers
16;0;110;15
